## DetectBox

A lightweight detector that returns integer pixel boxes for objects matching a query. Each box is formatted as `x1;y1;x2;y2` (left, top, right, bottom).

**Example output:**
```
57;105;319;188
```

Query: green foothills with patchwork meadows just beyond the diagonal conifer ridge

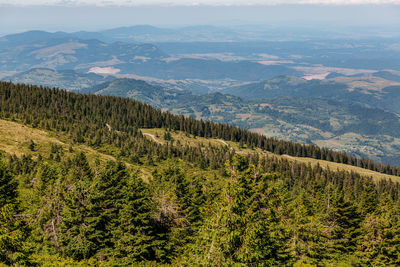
83;77;400;164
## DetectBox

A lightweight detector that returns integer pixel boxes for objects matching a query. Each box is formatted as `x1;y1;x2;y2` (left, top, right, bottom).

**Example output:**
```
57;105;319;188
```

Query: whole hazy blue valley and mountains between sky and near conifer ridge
0;25;400;165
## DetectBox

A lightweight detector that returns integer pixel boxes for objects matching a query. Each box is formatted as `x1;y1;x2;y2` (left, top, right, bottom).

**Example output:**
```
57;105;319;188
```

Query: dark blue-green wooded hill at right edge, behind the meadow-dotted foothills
222;74;400;113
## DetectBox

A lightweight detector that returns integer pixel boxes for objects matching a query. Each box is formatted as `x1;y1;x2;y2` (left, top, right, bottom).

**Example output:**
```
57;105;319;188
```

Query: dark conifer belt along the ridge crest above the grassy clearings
0;82;400;176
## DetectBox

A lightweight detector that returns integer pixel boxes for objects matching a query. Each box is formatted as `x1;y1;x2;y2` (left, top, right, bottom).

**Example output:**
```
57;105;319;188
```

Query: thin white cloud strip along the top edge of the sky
0;0;400;6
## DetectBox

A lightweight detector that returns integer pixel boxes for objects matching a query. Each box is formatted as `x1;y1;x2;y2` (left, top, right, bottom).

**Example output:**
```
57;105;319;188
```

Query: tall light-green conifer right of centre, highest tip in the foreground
186;155;284;265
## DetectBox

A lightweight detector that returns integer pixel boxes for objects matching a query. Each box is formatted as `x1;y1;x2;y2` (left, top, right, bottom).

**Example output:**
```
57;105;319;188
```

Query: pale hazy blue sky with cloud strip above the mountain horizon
0;0;400;35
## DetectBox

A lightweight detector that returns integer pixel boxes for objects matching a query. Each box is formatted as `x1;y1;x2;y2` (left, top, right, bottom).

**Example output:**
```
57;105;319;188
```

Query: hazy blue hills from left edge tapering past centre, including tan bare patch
0;31;301;81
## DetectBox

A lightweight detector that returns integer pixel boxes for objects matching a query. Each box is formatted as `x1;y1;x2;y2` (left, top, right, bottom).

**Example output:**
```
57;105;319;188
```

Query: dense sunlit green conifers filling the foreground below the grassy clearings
0;152;400;266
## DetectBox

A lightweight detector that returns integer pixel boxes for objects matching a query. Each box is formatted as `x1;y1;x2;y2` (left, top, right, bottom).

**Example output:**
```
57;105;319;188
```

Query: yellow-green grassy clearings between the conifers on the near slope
0;120;400;182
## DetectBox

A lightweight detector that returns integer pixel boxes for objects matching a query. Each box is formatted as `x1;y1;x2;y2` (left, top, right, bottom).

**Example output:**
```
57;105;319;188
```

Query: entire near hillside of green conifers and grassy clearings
0;82;400;266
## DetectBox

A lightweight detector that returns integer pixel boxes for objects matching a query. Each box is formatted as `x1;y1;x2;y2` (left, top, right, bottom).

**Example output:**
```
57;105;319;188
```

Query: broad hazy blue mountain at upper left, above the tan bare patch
0;32;166;71
